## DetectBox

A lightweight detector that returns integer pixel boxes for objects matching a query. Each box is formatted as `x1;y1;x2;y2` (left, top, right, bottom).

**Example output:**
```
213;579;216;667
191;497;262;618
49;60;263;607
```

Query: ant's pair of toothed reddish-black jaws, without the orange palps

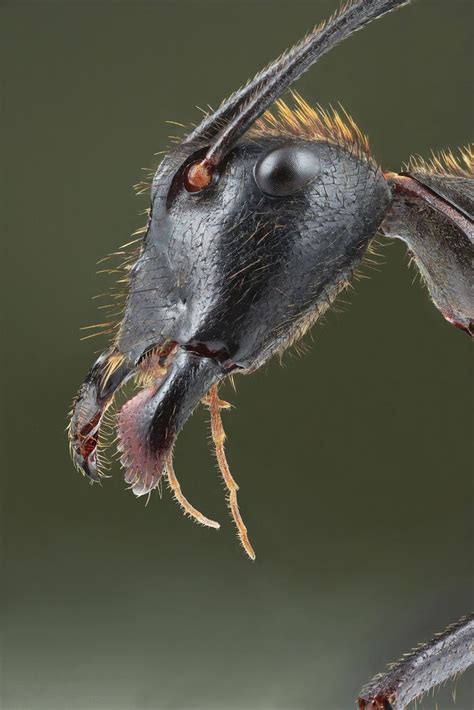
69;347;222;496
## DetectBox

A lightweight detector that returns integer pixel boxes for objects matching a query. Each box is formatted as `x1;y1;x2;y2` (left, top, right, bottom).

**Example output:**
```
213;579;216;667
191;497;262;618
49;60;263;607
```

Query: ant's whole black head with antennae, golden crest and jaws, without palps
71;0;403;495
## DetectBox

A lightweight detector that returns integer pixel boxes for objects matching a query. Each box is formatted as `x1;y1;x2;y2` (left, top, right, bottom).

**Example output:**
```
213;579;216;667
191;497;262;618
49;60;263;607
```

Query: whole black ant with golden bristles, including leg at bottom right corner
69;0;474;710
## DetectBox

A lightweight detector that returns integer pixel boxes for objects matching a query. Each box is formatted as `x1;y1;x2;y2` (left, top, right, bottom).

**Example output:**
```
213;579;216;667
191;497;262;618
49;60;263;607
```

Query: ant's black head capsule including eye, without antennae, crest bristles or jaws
117;136;390;373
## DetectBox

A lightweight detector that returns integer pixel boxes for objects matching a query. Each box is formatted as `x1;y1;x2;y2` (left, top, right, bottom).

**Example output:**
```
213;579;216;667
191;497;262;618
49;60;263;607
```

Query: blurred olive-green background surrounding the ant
0;0;473;710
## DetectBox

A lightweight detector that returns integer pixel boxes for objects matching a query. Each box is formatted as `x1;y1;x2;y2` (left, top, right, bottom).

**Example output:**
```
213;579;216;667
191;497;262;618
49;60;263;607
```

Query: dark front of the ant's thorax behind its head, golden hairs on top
381;146;474;337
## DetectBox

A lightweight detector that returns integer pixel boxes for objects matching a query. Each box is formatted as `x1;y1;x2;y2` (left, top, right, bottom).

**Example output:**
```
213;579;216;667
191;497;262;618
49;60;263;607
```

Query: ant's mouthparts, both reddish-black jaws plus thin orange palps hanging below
69;344;255;560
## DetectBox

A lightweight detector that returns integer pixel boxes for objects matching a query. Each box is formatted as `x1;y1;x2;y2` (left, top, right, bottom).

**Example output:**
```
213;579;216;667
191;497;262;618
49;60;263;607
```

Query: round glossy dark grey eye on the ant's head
254;143;320;197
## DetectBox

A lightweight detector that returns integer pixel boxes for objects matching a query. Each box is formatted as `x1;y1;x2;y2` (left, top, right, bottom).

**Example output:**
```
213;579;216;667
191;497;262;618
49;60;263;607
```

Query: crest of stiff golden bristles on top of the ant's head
247;91;370;158
